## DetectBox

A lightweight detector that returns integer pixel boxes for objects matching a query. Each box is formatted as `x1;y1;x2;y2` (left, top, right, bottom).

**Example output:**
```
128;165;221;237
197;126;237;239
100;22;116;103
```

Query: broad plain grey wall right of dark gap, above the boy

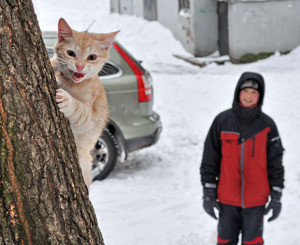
228;0;300;60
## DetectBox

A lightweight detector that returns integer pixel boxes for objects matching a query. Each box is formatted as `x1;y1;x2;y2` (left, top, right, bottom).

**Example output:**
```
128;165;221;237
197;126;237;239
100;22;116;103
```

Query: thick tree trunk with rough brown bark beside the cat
0;0;104;245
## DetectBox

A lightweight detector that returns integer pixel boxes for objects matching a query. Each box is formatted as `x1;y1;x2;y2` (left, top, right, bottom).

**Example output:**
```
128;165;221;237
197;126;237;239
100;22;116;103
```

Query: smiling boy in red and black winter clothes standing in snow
200;72;284;245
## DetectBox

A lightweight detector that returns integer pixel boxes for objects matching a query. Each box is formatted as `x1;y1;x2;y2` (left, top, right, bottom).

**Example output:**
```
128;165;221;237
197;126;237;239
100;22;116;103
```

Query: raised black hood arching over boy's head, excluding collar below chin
233;72;265;108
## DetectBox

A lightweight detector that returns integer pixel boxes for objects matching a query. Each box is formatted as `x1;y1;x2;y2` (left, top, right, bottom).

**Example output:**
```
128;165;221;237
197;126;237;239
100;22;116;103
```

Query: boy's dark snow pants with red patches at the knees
217;203;265;245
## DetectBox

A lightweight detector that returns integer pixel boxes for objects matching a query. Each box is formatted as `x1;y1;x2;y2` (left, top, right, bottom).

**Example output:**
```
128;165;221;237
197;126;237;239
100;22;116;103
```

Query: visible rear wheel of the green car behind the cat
91;129;118;180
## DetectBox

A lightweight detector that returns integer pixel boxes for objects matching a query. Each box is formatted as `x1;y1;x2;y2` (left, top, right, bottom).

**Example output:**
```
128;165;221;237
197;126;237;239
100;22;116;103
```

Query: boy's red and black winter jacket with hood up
200;72;284;208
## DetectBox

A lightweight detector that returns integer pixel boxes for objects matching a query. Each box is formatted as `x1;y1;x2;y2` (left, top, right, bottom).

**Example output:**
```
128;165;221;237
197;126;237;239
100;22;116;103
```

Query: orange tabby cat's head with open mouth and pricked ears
55;19;118;83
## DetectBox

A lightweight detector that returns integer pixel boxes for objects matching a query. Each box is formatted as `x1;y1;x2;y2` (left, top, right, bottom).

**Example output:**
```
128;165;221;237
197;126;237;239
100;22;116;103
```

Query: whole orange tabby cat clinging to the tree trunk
51;18;118;187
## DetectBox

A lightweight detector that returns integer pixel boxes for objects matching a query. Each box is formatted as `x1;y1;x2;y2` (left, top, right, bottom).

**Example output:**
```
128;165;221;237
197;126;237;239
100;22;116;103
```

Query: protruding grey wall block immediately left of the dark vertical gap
157;0;218;56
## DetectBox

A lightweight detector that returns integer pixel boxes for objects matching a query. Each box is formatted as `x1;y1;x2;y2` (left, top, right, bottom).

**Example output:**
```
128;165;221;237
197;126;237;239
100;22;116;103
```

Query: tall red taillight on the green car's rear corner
113;43;152;102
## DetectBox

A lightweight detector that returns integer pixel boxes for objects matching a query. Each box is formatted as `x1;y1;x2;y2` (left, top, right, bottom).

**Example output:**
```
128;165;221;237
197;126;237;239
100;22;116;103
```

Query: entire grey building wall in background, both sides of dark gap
111;0;300;61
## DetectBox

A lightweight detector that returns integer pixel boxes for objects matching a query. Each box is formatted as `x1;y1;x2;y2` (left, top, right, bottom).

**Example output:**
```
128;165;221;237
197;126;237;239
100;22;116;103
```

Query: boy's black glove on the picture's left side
203;187;220;219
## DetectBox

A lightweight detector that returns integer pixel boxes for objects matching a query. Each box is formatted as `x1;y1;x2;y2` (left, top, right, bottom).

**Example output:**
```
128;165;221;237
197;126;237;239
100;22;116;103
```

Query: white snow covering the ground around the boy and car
33;0;300;245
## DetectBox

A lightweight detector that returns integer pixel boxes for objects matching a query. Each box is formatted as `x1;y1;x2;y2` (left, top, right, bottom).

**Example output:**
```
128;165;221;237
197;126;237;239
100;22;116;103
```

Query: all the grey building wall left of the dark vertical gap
111;0;218;56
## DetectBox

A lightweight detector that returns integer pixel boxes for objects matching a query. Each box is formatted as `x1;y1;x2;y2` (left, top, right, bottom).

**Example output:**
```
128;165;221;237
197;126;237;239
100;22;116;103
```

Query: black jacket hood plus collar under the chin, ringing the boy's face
232;72;265;123
